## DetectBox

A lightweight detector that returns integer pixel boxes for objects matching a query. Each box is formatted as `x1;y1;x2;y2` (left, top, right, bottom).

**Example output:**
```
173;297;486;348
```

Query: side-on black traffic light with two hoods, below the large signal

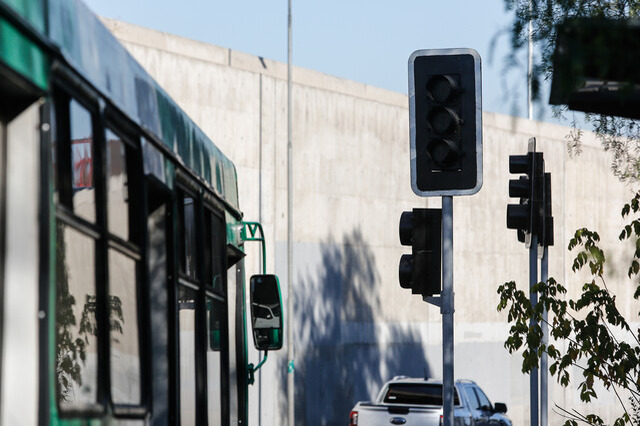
398;209;442;297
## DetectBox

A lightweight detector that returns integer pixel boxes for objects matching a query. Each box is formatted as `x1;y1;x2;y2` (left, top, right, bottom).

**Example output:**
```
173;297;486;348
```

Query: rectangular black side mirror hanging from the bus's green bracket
249;275;283;351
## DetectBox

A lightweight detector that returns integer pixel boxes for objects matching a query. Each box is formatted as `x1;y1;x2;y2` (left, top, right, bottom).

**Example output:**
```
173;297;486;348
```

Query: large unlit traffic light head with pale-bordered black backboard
409;49;482;196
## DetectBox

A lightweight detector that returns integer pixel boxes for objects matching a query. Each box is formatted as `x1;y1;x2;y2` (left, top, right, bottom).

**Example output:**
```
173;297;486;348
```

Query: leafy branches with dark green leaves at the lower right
498;192;640;425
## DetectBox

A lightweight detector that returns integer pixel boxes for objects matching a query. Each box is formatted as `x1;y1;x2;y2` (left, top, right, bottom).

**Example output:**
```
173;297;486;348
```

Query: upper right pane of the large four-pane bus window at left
107;130;129;240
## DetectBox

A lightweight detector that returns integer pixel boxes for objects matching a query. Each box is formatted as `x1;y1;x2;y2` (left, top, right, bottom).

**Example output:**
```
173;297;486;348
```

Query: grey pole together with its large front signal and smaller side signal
408;49;482;426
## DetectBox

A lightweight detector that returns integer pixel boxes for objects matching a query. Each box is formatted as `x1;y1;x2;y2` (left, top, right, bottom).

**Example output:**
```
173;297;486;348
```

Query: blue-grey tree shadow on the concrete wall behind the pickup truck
279;229;431;426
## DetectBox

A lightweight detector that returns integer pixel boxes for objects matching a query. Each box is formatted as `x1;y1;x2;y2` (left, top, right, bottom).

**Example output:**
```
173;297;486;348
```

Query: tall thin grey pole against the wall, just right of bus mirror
287;0;295;426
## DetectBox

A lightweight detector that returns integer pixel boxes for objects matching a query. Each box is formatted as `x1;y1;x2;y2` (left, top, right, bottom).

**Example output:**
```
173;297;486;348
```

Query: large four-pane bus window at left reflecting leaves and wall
52;90;147;416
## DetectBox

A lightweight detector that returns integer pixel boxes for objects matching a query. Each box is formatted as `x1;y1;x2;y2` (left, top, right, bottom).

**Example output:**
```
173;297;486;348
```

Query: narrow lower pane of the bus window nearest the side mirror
207;298;225;426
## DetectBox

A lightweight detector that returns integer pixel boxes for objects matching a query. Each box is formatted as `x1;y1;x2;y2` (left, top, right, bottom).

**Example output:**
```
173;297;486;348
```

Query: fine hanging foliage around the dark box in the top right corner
505;0;640;181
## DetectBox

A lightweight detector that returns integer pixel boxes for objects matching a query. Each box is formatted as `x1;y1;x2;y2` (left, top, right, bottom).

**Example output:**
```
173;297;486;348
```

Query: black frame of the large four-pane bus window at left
51;76;150;420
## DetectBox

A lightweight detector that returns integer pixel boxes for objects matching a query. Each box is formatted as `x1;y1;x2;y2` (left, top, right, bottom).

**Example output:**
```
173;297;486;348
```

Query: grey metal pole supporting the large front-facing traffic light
440;196;454;426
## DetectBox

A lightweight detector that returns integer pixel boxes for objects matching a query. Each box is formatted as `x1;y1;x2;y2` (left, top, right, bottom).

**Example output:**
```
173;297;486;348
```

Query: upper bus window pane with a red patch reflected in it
70;100;96;222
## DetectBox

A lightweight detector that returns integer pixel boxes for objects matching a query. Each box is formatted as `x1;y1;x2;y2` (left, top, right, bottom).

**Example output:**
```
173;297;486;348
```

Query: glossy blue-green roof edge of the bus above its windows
0;0;239;211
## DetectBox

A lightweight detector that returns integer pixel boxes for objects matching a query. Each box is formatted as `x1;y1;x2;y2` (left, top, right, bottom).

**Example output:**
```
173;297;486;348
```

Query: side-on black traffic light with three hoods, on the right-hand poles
507;151;544;246
